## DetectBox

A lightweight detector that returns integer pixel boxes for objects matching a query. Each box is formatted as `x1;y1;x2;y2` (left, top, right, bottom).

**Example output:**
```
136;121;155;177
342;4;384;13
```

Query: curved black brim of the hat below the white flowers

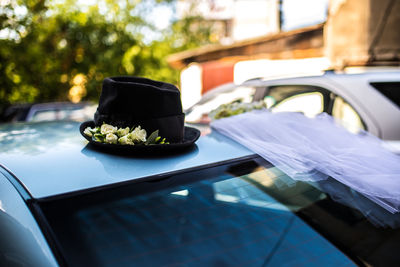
79;121;200;154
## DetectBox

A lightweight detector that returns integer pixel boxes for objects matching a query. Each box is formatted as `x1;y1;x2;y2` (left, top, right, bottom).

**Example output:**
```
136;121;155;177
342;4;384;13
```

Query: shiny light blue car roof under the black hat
0;121;254;201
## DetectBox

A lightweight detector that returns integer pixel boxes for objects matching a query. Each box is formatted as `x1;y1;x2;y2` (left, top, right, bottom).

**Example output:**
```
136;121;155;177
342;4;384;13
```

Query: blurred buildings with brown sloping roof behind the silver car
168;0;400;110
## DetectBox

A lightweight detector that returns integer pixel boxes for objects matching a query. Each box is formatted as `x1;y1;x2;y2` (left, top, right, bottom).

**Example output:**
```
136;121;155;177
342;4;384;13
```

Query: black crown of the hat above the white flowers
94;77;185;142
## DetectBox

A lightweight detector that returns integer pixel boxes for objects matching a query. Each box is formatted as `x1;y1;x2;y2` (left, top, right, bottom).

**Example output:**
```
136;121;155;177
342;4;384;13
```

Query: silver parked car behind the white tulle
187;70;400;140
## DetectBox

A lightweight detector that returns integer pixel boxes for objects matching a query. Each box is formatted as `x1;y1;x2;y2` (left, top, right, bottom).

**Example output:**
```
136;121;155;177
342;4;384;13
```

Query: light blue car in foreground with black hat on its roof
0;121;400;266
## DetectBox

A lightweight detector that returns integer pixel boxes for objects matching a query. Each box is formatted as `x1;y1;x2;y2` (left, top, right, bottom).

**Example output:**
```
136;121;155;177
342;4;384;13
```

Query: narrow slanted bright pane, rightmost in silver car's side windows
332;96;366;133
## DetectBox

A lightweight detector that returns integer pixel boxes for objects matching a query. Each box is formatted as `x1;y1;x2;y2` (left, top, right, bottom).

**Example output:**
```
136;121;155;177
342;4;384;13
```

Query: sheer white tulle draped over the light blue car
211;110;400;213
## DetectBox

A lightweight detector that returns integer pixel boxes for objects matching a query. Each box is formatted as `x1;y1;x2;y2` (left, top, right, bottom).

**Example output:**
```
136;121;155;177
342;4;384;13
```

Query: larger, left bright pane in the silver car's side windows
271;92;324;117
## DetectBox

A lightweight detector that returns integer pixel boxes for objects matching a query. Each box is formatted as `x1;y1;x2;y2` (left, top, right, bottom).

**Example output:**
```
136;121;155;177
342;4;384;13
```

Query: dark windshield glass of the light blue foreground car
38;158;400;266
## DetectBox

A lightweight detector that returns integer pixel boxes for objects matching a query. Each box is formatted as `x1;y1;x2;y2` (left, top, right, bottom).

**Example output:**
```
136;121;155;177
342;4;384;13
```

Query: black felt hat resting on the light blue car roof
80;76;200;152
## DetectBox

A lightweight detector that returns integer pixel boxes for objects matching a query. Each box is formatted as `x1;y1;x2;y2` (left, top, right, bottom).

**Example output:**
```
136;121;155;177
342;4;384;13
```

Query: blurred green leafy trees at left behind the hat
0;0;214;111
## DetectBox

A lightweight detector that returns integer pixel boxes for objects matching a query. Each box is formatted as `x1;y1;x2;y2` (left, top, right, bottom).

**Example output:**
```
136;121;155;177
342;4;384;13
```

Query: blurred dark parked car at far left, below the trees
0;102;97;122
